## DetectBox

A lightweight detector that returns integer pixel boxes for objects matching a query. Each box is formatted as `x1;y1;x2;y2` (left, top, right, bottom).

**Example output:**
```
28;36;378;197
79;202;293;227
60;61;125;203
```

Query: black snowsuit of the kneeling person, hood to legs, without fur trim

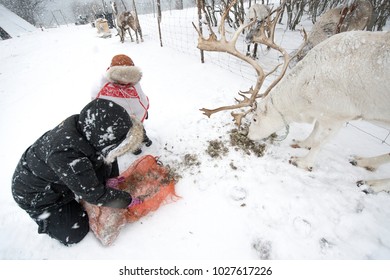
12;99;139;245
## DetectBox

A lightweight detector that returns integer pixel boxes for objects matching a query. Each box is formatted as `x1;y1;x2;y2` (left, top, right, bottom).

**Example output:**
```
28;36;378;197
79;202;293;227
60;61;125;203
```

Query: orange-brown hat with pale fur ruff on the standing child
106;54;142;85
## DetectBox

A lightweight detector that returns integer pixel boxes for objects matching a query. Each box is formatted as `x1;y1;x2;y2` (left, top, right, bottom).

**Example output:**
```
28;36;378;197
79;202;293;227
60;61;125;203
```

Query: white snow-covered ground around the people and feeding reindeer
0;6;390;272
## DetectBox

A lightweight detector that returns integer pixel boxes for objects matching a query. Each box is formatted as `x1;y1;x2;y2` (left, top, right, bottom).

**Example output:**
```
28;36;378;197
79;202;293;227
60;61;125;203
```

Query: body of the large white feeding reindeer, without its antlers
248;31;390;191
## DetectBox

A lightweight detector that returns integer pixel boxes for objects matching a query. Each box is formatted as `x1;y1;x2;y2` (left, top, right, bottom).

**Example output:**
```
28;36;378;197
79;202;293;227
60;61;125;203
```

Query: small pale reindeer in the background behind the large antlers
245;4;271;58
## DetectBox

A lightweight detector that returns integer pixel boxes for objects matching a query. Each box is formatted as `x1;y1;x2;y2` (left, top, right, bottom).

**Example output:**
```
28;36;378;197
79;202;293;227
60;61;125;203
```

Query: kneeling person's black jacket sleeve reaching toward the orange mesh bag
48;150;132;208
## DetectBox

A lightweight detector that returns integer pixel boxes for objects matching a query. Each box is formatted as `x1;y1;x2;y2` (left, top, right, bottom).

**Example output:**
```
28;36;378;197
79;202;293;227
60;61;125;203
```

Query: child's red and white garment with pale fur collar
97;66;149;122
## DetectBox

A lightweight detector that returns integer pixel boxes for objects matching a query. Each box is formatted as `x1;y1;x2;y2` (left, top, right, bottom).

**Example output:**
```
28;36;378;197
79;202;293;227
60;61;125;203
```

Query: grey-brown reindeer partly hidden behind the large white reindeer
290;0;373;67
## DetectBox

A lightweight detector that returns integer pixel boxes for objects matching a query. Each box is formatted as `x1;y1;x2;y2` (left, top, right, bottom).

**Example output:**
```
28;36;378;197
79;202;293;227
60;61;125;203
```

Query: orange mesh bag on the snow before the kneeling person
83;155;179;246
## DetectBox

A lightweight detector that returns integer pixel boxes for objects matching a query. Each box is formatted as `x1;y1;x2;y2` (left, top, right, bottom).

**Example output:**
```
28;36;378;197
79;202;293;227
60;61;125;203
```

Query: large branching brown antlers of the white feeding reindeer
192;0;306;126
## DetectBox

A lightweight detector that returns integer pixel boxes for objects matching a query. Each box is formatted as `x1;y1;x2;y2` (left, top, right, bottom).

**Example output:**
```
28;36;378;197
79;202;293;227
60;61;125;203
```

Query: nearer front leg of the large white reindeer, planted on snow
290;120;342;171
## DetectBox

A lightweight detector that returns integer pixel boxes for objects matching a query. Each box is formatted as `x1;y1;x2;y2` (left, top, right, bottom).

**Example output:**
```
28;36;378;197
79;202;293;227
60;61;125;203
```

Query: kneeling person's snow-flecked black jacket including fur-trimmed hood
12;99;143;213
